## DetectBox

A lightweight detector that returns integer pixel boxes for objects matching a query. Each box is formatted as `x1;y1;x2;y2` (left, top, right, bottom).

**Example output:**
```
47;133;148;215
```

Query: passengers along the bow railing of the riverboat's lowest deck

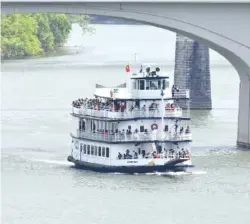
117;148;190;159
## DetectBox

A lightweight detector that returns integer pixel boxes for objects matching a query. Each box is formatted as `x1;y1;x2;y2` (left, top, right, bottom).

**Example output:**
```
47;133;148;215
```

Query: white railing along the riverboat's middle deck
76;130;192;142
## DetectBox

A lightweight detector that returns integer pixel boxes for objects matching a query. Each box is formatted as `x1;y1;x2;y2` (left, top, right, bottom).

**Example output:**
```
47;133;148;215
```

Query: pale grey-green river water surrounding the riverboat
1;25;250;224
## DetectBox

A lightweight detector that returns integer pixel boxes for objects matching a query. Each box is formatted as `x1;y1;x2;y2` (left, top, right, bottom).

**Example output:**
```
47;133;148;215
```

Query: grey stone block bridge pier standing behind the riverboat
174;34;212;110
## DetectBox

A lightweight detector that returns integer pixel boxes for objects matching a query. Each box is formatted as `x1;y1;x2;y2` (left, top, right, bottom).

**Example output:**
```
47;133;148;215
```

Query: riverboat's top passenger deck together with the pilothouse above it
72;66;190;121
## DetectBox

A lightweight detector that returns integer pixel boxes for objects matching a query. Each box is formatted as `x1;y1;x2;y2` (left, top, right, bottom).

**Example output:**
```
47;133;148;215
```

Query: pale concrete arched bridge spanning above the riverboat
1;0;250;148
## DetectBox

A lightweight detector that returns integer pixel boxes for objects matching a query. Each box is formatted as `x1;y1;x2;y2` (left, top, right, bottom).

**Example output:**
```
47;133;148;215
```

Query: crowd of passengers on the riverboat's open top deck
72;98;179;112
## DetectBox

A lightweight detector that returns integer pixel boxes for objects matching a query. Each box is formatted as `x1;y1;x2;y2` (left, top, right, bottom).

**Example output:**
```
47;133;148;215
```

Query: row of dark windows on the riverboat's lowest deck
80;144;109;158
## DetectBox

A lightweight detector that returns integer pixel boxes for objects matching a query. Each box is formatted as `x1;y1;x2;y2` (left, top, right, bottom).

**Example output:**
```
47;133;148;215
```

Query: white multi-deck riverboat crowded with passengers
68;65;193;174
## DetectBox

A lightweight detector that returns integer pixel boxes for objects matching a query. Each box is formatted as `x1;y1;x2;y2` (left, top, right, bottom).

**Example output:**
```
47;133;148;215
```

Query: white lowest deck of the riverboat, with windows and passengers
70;139;191;168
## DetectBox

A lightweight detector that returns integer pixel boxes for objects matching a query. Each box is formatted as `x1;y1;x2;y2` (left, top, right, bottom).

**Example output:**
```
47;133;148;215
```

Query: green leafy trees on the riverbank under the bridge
1;13;92;58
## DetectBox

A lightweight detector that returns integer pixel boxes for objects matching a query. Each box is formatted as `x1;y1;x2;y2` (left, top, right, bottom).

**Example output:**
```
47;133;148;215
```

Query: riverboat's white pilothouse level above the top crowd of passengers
94;66;190;101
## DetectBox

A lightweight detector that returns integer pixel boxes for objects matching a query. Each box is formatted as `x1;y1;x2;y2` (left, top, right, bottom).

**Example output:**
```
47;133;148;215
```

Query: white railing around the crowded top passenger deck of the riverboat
73;107;183;119
